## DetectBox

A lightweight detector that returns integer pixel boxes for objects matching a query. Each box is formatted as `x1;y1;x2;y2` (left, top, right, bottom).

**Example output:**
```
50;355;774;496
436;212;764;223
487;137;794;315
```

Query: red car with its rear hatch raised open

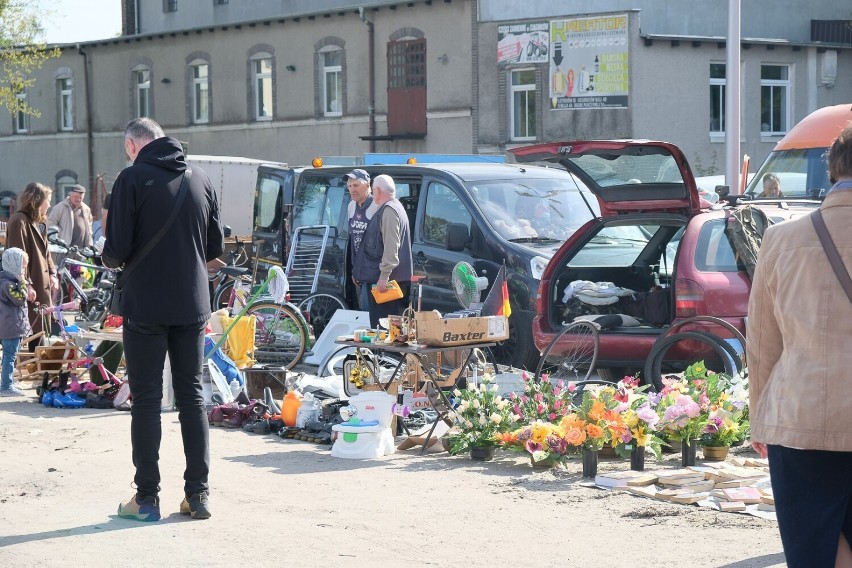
513;140;818;380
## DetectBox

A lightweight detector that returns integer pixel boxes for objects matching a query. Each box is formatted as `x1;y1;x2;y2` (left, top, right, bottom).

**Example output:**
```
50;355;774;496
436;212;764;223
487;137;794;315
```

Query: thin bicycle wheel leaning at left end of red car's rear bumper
535;321;600;382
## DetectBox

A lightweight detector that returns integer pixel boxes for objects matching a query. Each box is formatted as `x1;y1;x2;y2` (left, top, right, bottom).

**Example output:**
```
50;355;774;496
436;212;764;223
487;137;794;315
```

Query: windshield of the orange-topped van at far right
746;148;831;199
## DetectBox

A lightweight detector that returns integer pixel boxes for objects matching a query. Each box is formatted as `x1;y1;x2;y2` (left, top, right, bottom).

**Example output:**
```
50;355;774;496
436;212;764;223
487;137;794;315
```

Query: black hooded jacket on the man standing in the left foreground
102;137;224;325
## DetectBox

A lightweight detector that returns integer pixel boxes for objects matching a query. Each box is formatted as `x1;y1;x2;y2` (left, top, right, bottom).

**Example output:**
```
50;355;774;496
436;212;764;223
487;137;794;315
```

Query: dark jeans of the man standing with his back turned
124;318;210;496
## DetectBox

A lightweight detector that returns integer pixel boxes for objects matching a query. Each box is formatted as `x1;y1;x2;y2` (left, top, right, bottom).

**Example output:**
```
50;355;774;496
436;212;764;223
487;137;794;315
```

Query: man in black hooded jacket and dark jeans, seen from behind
102;118;224;521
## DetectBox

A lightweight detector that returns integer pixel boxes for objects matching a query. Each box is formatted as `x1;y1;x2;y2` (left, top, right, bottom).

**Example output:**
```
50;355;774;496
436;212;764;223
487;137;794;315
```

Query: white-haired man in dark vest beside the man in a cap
352;175;413;327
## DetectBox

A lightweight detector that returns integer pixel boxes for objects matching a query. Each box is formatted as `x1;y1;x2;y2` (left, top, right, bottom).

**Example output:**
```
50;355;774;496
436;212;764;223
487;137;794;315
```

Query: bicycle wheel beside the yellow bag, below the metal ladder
246;301;308;369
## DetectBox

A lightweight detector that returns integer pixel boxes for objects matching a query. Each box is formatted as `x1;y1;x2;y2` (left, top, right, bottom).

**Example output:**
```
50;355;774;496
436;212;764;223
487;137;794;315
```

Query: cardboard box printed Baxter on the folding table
415;311;509;346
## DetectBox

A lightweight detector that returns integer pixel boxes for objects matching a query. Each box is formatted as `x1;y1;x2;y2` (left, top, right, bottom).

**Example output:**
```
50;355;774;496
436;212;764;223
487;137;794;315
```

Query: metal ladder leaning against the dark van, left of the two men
285;225;331;304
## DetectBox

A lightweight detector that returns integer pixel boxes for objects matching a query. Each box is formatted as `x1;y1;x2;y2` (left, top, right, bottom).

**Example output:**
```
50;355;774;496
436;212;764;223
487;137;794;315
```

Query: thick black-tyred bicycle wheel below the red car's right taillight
645;331;739;391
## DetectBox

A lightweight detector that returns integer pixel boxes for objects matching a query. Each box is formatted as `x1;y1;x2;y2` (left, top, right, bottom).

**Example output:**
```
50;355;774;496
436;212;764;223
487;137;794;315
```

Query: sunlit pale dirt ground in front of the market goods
0;391;784;568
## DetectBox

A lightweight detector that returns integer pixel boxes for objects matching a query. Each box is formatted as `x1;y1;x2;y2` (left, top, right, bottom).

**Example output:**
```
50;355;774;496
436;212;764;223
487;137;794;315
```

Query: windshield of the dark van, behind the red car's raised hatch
468;179;600;242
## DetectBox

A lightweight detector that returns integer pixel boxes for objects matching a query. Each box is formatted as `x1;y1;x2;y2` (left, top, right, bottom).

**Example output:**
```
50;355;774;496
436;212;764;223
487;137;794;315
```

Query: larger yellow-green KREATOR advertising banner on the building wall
549;14;629;110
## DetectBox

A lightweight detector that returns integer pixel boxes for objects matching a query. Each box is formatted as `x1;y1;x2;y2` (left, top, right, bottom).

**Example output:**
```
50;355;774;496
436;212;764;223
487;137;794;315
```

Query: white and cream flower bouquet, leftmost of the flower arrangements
449;375;512;454
